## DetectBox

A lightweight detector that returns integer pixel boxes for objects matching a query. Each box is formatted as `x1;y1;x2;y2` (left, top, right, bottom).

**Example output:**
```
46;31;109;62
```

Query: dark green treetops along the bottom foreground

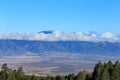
0;61;120;80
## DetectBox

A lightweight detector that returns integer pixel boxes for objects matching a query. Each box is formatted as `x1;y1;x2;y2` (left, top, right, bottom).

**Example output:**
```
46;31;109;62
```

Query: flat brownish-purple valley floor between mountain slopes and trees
0;52;120;75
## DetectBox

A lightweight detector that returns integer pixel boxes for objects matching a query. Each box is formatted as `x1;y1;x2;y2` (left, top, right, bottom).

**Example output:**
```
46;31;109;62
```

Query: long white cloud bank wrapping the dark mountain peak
0;30;120;42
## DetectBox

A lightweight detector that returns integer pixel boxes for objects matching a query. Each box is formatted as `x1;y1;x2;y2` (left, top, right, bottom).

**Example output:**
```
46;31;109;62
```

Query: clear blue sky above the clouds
0;0;120;34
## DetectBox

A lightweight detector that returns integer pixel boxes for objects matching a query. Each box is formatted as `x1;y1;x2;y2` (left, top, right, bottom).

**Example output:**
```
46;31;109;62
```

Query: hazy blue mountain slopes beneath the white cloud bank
0;39;120;56
